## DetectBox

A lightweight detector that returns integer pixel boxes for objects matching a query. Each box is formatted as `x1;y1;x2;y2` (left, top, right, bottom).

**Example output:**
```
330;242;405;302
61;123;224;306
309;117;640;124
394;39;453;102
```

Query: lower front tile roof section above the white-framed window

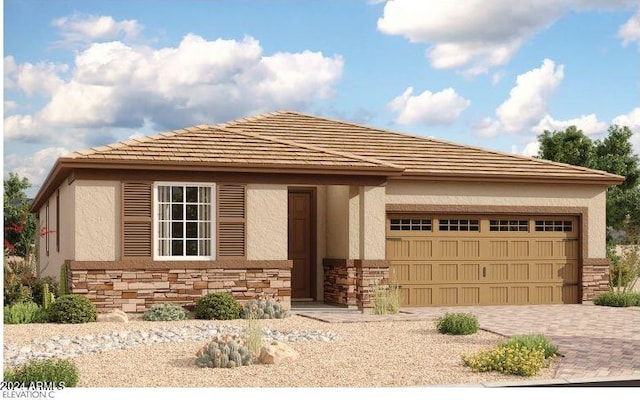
63;125;402;171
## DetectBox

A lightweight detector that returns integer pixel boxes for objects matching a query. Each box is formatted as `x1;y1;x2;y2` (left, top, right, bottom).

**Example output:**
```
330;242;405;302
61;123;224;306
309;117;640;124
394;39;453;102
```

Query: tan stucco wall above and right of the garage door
386;181;606;258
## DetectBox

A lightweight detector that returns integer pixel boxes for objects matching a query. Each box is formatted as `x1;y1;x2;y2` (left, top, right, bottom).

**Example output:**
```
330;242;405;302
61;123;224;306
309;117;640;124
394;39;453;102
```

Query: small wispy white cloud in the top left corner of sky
52;14;142;44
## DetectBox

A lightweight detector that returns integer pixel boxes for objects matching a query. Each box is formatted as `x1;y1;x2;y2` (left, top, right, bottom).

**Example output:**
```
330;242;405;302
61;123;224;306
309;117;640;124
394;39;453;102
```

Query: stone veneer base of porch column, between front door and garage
323;258;389;309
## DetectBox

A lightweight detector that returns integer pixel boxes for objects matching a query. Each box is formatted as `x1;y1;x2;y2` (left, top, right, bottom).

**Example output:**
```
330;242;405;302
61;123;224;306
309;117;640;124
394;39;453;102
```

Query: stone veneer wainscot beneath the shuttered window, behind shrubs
69;261;291;312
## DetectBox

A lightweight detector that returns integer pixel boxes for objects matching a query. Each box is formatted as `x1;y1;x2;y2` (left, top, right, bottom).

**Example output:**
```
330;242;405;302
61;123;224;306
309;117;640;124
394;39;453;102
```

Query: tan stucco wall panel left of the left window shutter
74;181;121;261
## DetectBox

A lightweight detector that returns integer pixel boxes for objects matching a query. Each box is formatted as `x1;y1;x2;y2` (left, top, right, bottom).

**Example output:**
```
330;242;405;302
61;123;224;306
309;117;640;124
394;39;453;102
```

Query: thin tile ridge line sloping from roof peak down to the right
261;110;624;178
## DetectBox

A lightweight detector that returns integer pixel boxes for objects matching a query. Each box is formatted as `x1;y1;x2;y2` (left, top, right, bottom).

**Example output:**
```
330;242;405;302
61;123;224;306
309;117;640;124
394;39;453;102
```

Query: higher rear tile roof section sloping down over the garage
220;111;622;183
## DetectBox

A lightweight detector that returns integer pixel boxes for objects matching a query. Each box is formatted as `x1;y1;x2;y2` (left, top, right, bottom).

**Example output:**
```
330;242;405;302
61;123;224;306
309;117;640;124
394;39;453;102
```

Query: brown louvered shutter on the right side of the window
216;184;246;258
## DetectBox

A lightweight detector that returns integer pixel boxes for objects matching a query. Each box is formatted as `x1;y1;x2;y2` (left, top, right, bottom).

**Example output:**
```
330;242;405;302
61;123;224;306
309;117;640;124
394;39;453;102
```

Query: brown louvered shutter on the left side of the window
122;182;153;259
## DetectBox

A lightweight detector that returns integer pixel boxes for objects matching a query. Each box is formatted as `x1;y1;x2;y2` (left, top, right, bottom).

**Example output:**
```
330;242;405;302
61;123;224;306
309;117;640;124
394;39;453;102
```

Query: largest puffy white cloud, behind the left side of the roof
5;34;344;147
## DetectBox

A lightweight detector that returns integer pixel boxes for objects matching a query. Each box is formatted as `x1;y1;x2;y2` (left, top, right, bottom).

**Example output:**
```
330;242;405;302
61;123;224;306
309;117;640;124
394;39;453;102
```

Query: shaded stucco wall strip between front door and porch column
326;185;349;258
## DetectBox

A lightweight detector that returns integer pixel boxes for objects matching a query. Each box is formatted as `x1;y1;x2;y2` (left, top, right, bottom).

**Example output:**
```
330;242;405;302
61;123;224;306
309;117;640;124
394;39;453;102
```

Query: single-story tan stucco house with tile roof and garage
31;111;624;312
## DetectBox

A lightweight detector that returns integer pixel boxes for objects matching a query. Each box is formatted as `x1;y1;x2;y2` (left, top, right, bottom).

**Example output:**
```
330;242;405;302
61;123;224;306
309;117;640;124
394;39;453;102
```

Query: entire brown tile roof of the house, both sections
61;111;623;184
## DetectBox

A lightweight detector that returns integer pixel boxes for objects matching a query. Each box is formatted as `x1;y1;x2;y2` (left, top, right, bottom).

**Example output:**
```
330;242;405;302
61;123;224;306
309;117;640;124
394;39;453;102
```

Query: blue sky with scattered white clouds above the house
3;0;640;197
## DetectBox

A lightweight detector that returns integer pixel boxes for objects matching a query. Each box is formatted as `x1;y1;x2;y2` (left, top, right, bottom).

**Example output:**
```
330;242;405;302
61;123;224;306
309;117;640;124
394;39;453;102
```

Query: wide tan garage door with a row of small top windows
386;214;580;307
